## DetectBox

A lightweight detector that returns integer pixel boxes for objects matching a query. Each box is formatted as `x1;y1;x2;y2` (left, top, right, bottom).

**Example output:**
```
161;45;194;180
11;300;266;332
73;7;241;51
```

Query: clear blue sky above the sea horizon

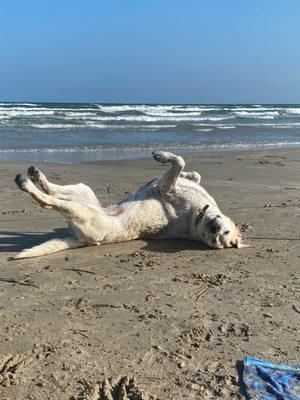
0;0;300;103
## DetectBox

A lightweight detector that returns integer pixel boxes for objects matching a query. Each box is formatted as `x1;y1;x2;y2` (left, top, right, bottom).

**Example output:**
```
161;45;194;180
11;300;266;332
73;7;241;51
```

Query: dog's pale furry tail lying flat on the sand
12;237;84;260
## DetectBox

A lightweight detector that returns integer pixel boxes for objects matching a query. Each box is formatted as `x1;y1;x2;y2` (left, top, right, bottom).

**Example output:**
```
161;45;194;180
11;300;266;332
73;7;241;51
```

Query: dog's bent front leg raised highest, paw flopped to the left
152;151;185;193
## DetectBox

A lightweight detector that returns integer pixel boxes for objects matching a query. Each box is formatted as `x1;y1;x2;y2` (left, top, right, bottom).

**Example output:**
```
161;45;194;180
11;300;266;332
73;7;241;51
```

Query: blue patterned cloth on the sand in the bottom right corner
243;357;300;400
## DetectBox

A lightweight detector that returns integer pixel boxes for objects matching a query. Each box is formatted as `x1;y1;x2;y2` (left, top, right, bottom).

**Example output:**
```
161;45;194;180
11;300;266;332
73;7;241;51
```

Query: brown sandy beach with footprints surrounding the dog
0;149;300;400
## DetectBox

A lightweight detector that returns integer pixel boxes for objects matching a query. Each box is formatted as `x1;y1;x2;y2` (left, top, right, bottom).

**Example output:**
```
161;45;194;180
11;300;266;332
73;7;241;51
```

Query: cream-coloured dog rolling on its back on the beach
14;151;248;259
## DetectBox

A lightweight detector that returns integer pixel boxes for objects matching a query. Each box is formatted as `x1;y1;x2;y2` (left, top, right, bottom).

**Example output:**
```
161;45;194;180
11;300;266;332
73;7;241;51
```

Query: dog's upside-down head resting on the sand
195;204;249;249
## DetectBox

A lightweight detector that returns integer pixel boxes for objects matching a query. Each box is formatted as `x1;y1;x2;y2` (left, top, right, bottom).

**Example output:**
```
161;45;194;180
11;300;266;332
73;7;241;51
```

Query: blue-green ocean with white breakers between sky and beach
0;102;300;163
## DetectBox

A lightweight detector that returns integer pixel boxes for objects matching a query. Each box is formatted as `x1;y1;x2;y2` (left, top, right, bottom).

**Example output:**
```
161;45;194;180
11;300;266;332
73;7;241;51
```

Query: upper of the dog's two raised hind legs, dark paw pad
28;167;101;207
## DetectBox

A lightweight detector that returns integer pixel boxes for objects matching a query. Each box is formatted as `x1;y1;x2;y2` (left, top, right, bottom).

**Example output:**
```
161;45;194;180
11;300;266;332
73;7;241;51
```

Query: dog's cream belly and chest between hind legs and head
111;178;216;239
